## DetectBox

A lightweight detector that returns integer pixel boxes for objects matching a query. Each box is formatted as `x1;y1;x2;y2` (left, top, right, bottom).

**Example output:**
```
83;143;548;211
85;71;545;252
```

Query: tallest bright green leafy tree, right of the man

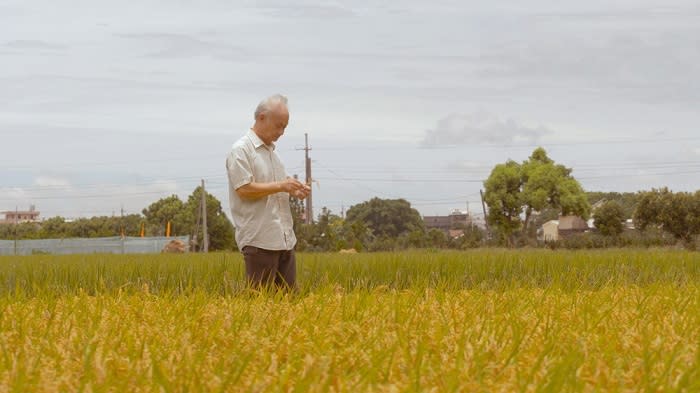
484;147;590;243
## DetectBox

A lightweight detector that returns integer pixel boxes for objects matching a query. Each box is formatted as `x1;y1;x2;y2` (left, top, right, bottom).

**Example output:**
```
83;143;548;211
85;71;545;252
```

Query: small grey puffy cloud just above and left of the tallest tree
422;112;551;147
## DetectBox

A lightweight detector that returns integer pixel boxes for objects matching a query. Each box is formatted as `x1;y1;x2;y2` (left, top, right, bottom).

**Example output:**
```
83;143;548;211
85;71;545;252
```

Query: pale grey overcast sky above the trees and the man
0;0;700;218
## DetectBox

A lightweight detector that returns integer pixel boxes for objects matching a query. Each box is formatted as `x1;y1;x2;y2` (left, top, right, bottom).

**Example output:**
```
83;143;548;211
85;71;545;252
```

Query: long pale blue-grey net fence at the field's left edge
0;236;189;255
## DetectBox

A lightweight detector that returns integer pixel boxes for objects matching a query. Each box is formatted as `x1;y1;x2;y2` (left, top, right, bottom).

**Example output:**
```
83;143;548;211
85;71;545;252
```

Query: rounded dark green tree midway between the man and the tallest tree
345;198;425;238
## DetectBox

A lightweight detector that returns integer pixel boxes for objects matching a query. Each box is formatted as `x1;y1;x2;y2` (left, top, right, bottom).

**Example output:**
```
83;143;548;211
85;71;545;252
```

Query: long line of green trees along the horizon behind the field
0;148;700;251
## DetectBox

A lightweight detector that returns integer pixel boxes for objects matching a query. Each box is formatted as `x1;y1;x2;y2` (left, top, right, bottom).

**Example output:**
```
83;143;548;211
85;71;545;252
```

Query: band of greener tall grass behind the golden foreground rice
0;250;700;295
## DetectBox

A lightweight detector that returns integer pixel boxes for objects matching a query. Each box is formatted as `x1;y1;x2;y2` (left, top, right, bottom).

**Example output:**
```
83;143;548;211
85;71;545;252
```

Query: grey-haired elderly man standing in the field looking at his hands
226;95;311;289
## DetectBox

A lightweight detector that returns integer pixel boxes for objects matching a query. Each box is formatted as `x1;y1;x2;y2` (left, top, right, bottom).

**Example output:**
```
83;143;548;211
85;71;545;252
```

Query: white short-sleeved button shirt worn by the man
226;130;297;250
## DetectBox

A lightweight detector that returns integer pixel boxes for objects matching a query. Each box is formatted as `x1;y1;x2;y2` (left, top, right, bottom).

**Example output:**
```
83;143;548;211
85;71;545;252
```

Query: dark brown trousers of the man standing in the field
241;246;297;289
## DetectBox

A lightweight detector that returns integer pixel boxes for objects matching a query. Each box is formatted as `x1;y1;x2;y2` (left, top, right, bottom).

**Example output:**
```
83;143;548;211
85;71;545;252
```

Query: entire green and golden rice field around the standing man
0;250;700;392
